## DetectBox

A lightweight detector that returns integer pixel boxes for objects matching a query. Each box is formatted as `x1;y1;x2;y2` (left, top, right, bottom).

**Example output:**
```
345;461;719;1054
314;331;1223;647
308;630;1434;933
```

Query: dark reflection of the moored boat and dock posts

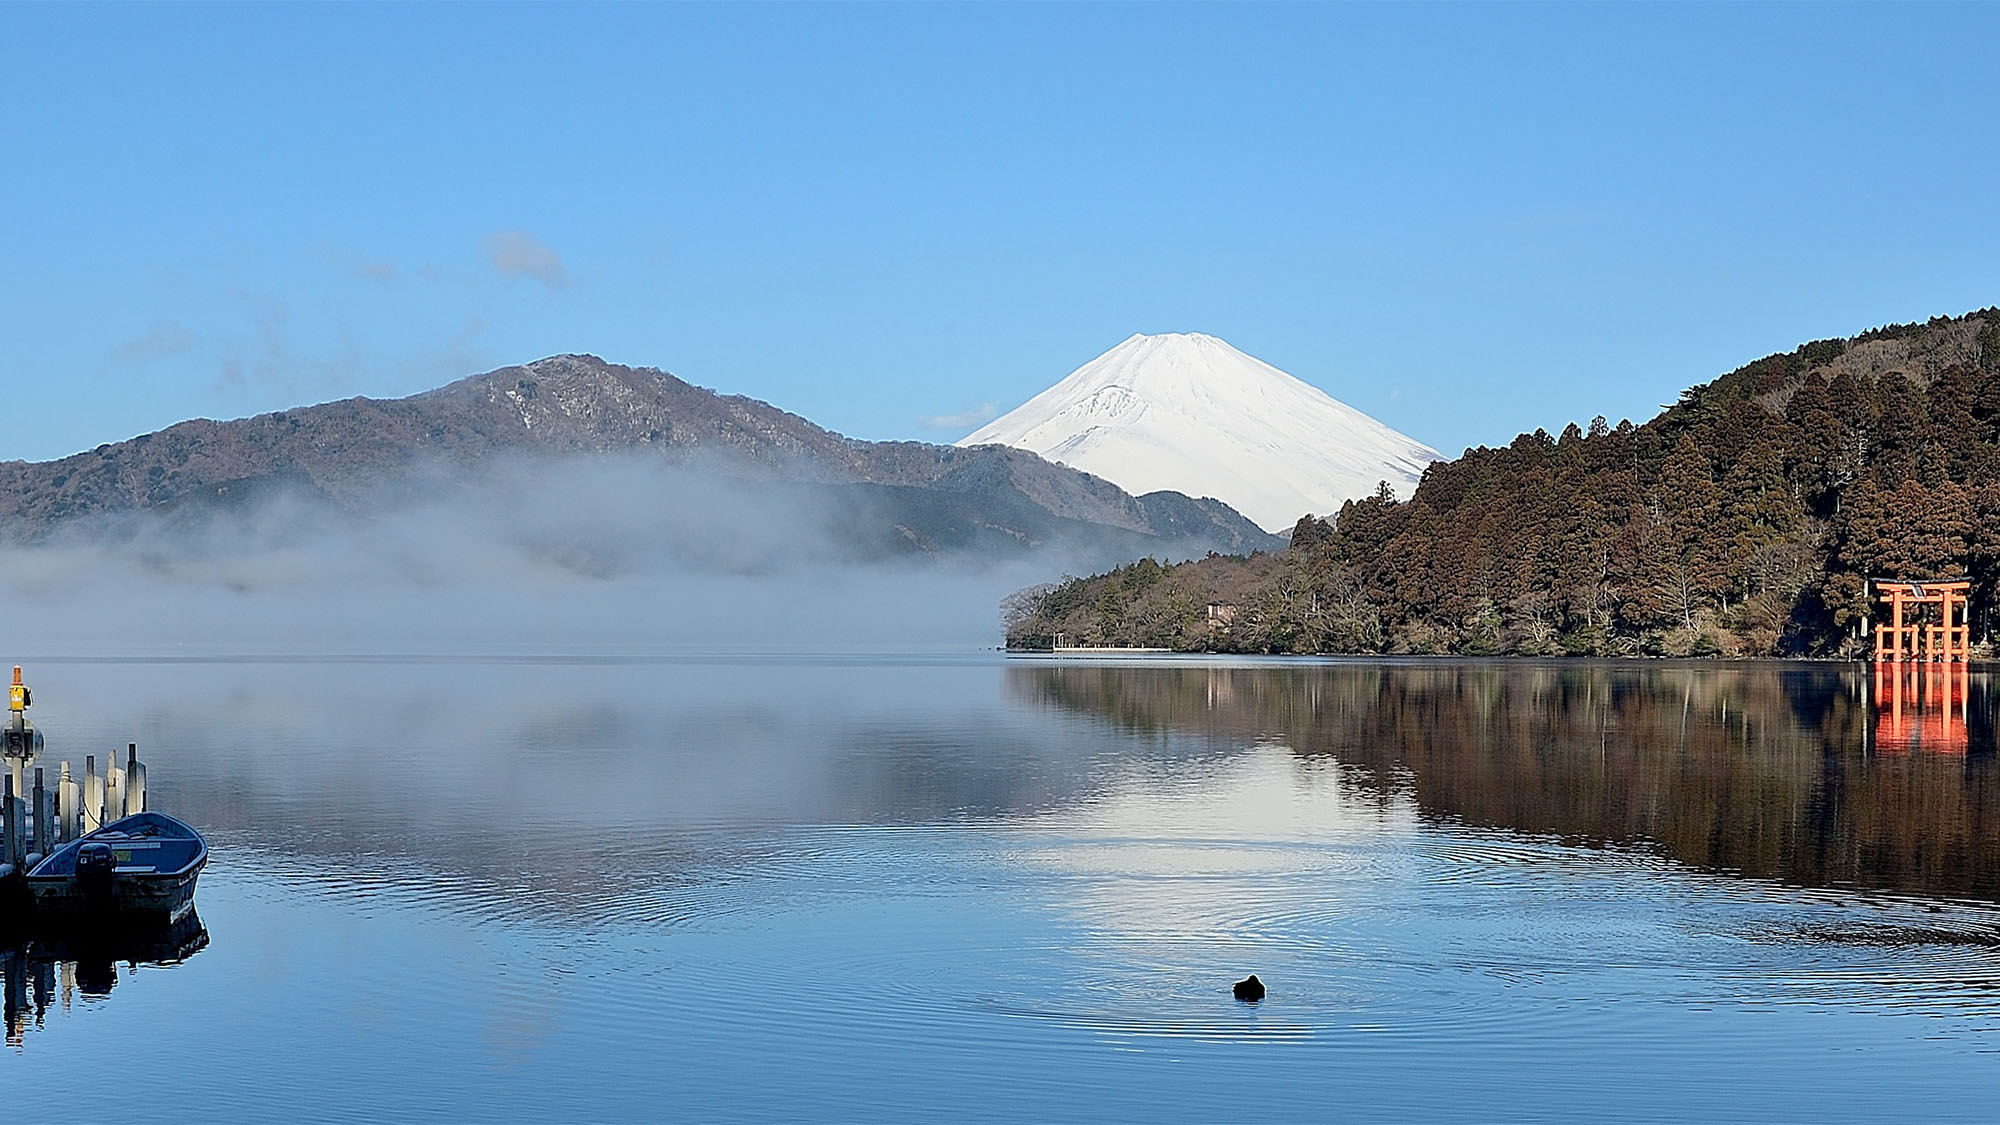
0;911;208;1047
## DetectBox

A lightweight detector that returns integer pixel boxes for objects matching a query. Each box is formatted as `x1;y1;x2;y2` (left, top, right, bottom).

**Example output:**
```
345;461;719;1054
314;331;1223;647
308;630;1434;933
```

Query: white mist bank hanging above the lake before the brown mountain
0;456;1096;655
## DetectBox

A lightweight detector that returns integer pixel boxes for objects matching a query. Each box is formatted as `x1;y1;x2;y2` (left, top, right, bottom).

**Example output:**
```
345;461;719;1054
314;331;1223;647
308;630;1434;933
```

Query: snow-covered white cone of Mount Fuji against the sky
958;332;1438;532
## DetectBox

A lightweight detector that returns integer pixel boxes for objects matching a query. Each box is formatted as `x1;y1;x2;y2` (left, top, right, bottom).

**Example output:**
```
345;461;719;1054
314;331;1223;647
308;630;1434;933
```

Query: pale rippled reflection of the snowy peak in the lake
964;743;1418;1041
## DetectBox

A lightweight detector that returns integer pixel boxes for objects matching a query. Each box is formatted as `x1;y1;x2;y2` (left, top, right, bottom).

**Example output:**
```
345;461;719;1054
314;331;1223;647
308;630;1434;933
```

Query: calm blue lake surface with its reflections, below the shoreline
0;653;2000;1121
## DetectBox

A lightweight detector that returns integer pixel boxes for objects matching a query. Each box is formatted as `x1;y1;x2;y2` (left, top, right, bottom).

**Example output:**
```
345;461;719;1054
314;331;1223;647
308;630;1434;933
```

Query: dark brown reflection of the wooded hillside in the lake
1012;663;2000;899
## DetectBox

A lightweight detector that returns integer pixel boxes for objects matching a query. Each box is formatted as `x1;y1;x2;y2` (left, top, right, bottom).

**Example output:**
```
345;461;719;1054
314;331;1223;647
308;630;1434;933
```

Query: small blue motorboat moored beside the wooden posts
28;813;208;921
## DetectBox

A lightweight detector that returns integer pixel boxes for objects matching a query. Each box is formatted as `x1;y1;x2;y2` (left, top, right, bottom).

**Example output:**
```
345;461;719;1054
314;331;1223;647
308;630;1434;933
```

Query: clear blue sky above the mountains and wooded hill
0;4;2000;460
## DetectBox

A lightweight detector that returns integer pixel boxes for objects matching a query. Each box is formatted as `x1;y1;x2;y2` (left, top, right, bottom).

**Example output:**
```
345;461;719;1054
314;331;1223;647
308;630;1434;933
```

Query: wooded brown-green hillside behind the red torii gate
1008;308;2000;657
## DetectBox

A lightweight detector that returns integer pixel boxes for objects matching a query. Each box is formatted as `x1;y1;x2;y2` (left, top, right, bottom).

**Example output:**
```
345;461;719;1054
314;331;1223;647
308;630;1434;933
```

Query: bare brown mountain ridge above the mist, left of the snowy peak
0;356;1272;552
